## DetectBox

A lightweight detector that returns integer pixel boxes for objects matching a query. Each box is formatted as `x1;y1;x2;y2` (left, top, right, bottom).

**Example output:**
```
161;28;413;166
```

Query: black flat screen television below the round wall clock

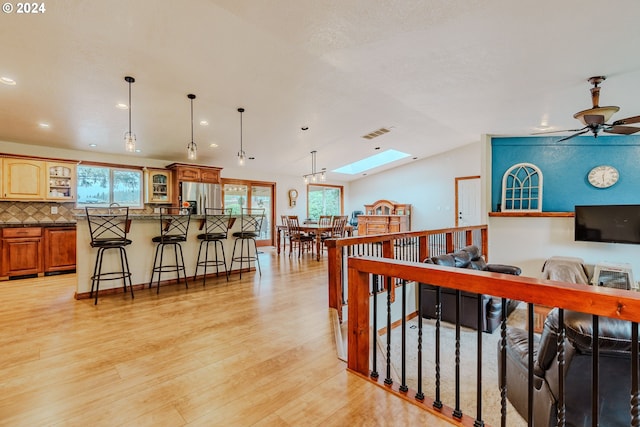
575;205;640;244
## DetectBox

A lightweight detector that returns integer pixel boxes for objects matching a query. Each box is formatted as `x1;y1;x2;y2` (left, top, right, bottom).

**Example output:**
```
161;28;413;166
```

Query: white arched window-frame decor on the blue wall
502;163;542;212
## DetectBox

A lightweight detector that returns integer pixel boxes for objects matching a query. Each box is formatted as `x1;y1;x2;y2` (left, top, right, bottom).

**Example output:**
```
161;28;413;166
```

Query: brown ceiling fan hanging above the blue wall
534;76;640;142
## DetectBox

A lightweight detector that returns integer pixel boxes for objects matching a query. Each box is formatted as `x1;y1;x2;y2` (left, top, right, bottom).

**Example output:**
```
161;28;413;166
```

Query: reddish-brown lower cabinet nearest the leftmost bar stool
44;227;76;273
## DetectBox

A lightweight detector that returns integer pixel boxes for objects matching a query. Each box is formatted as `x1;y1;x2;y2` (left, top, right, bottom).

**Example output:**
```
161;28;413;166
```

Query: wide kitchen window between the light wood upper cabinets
76;165;143;208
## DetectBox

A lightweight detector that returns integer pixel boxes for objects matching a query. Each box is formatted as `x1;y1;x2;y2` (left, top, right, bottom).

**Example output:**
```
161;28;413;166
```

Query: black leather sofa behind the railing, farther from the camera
420;245;521;333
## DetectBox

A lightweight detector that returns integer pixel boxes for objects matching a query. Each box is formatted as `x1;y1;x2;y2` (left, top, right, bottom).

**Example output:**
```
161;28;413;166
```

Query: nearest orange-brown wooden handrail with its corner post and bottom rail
347;256;640;426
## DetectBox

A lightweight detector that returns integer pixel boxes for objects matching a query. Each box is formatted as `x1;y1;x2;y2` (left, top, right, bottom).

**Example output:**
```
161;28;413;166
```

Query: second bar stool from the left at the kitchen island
149;208;191;293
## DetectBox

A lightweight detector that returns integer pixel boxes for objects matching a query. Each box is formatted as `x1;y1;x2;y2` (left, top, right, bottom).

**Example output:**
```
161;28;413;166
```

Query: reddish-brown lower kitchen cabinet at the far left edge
0;227;43;278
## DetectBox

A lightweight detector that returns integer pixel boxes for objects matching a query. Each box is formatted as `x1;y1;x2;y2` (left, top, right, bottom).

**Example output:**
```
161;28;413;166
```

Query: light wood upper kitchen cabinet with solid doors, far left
2;158;47;200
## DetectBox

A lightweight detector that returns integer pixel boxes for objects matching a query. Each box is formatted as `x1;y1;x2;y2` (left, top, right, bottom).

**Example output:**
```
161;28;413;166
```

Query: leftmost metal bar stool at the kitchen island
85;207;133;304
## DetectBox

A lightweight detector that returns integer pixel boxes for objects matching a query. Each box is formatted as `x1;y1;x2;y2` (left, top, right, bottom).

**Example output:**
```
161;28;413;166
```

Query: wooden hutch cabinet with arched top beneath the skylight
358;200;411;236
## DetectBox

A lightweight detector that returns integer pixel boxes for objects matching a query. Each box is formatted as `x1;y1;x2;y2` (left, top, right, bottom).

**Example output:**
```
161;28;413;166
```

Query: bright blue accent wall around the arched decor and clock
491;135;640;212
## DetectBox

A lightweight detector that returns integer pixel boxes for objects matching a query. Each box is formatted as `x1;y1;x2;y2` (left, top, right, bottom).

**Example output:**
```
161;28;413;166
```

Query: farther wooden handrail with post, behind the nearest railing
325;225;489;322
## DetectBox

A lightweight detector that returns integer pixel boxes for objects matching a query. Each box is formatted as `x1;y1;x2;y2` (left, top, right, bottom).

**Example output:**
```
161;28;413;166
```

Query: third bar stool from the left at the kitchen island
193;208;234;286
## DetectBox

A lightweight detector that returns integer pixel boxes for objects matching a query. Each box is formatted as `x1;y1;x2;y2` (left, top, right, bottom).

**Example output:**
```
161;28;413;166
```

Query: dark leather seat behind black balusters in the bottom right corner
498;309;631;427
